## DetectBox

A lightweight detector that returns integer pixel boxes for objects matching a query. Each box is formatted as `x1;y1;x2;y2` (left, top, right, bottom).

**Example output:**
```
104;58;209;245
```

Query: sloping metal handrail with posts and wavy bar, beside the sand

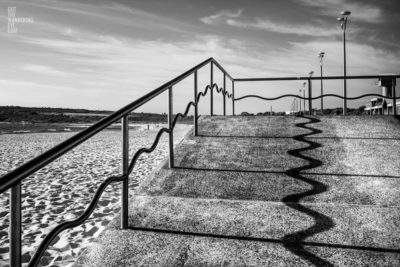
0;58;234;267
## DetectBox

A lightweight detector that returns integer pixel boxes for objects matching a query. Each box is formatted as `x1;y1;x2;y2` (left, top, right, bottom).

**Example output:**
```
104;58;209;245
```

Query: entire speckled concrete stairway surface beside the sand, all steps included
76;116;400;266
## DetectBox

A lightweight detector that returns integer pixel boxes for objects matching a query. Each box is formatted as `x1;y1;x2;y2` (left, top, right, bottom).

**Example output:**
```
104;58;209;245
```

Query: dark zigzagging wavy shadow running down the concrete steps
282;117;334;266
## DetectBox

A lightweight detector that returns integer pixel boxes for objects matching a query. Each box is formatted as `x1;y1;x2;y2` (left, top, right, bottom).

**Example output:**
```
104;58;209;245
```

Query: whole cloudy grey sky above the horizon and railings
0;0;400;114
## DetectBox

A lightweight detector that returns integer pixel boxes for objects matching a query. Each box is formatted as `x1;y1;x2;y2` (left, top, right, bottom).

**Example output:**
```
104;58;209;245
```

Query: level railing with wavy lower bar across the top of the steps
233;75;400;115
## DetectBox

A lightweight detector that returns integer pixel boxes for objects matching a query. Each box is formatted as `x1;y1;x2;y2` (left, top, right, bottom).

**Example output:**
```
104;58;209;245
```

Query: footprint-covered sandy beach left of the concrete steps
0;124;191;266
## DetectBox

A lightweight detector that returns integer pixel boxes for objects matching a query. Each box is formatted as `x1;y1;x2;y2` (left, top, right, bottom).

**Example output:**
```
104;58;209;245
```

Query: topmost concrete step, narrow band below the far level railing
199;116;400;139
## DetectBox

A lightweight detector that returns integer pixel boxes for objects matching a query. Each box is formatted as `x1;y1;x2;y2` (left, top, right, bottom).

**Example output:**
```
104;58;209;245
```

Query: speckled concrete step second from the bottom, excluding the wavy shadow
129;196;400;252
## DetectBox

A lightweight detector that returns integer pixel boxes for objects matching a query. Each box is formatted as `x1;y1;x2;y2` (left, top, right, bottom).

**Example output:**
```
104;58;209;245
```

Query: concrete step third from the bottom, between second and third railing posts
137;166;400;207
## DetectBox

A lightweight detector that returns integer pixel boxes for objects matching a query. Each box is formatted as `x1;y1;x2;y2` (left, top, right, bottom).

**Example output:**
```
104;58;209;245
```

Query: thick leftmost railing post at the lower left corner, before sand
9;183;22;267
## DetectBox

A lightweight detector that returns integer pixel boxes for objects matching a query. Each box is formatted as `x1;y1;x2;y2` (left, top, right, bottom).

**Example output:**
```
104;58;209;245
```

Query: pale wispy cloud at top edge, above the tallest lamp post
296;0;384;23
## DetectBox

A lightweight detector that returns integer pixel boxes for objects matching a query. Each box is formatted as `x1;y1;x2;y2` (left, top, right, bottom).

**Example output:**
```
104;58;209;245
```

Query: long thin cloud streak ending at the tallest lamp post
226;18;340;36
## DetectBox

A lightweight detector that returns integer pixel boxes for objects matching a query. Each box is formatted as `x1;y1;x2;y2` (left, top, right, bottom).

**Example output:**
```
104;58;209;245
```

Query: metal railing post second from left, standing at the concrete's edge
121;115;129;229
